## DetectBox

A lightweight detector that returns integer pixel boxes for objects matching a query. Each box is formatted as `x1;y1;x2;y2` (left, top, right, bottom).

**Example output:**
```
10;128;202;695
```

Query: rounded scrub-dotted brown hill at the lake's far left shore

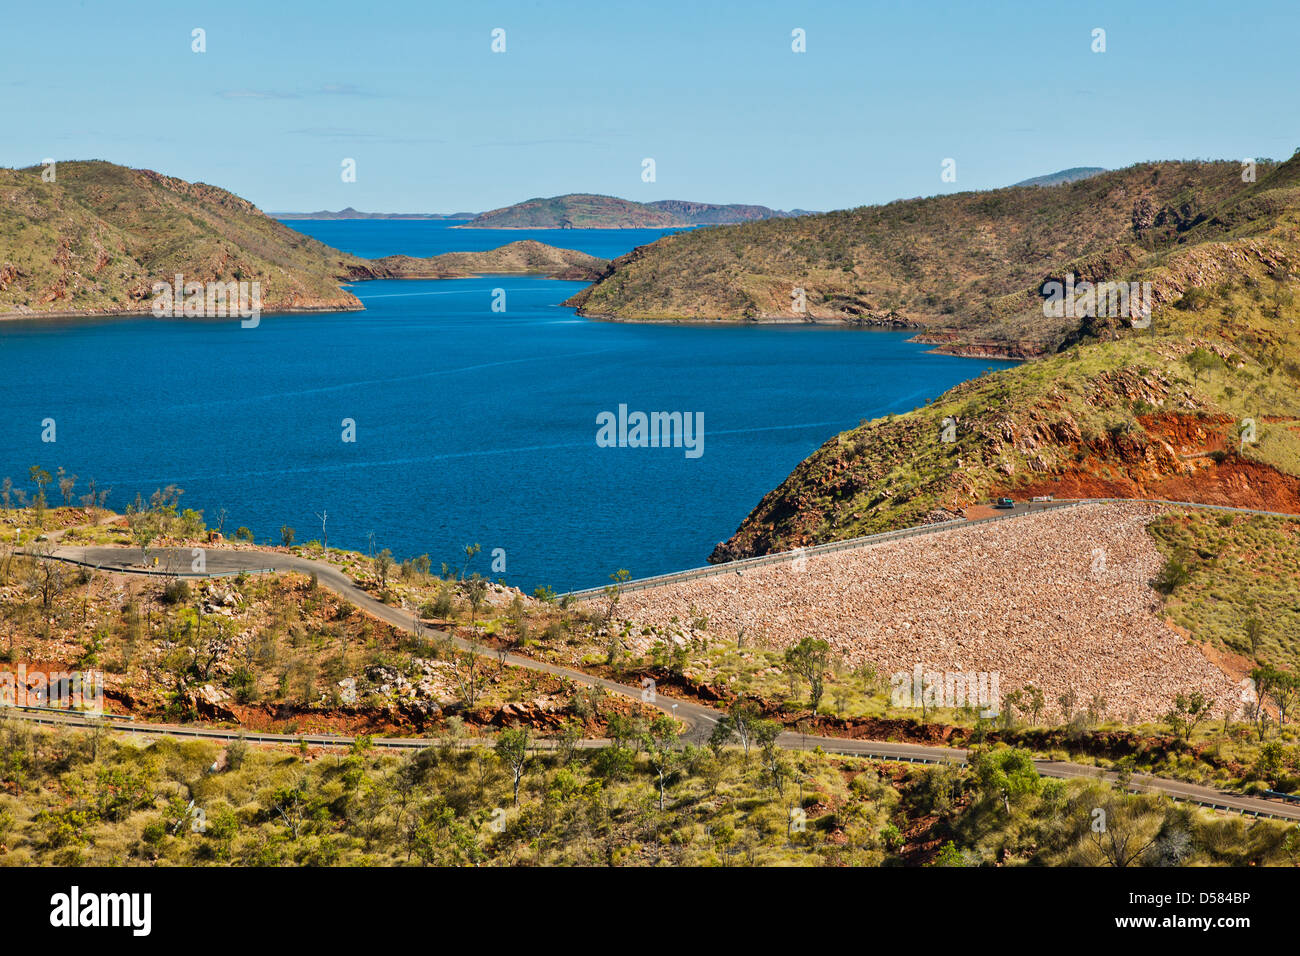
0;161;368;315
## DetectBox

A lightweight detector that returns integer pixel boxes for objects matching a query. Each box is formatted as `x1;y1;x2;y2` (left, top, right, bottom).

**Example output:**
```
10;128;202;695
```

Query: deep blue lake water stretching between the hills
0;220;1009;591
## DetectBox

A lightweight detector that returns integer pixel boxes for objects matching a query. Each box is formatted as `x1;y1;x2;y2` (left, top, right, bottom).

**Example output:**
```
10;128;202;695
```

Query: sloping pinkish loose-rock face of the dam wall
619;503;1242;721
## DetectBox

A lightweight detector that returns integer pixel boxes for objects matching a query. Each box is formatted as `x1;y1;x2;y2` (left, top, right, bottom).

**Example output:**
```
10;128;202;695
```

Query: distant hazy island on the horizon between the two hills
455;193;810;229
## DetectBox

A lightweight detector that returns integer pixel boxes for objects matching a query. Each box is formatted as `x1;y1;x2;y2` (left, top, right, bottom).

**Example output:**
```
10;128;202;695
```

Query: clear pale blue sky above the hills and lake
0;0;1300;212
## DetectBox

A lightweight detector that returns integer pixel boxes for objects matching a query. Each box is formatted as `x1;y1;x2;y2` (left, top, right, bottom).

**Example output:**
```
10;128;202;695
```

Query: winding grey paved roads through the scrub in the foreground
22;546;1300;822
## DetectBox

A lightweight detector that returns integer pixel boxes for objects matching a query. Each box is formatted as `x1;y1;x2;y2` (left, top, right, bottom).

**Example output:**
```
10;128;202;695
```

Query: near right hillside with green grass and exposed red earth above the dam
707;159;1300;561
